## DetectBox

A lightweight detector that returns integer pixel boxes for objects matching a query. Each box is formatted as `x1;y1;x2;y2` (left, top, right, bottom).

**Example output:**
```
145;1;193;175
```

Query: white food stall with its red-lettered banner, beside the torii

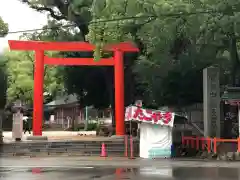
125;106;174;158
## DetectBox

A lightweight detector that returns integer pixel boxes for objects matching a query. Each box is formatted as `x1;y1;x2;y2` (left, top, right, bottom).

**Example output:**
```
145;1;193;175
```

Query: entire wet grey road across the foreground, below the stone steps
0;157;240;180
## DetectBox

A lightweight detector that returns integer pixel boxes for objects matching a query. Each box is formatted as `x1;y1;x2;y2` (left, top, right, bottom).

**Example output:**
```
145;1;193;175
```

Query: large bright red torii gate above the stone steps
8;40;139;136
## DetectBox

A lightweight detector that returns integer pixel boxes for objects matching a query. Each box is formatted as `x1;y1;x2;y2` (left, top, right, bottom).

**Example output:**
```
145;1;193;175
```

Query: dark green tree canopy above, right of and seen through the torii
12;0;240;109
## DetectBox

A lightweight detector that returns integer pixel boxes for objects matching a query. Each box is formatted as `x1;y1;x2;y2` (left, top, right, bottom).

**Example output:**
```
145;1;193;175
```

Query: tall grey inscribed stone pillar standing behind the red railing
203;67;220;137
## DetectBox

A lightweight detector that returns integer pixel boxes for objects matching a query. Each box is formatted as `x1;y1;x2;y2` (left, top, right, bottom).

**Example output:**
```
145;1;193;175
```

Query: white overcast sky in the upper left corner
0;0;47;52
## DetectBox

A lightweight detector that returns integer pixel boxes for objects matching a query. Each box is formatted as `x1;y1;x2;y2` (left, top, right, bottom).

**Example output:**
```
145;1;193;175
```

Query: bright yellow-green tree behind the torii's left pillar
4;51;64;104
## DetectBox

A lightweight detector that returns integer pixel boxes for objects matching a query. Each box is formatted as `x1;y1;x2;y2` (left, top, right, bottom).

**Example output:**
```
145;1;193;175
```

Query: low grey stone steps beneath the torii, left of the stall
0;132;138;157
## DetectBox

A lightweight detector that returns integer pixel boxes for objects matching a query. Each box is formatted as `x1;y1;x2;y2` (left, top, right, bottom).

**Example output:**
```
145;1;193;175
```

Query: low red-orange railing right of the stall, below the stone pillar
182;136;240;153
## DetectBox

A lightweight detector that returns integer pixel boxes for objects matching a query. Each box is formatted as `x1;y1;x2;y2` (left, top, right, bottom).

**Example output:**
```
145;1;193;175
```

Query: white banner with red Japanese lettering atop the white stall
125;106;174;127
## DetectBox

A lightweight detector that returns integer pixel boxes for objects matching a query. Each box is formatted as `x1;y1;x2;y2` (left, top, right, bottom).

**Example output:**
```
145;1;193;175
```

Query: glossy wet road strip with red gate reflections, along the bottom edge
0;166;240;180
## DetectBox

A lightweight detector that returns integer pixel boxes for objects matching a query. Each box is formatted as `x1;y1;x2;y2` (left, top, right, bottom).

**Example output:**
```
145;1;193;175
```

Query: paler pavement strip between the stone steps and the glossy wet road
0;157;240;168
